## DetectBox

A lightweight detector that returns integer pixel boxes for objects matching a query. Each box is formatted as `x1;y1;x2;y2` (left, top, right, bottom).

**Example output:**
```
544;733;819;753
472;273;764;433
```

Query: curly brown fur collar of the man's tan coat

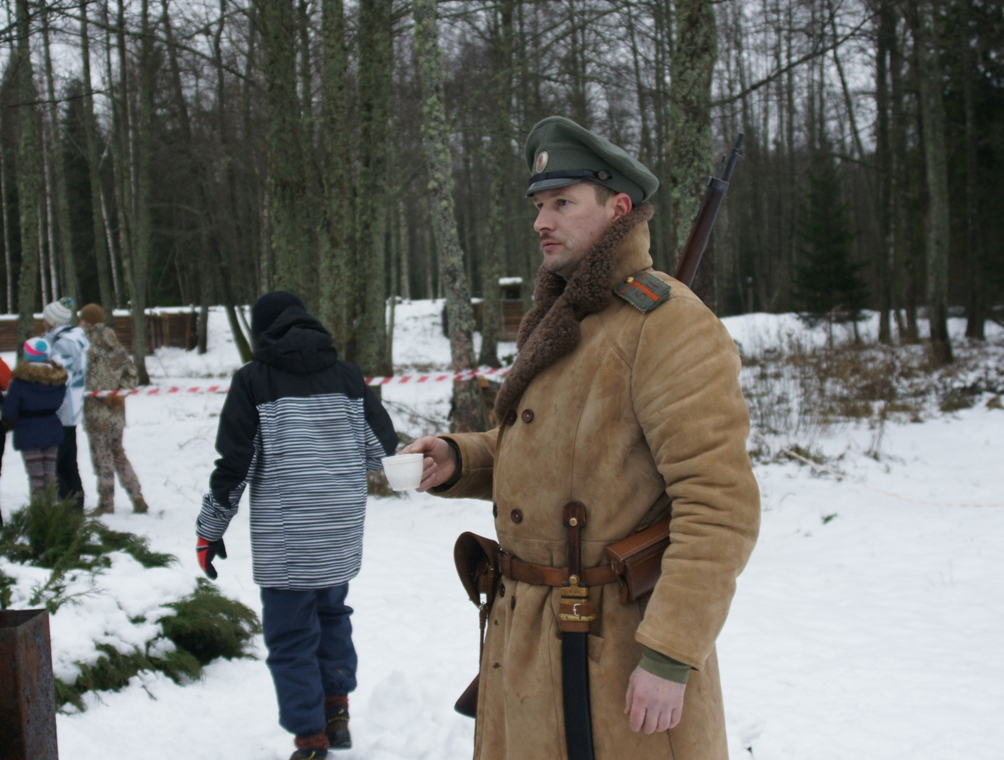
495;203;654;423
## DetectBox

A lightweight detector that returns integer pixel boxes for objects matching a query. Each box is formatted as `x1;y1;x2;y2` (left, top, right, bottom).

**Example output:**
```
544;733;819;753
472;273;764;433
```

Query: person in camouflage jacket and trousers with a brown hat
80;303;148;514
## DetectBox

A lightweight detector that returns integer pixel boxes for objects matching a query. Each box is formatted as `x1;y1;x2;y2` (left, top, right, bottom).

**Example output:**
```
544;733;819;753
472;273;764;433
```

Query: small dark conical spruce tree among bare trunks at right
793;139;867;336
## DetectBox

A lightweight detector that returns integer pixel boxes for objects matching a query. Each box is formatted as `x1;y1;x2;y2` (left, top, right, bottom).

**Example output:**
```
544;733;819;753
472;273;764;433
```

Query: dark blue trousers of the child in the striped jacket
261;583;356;736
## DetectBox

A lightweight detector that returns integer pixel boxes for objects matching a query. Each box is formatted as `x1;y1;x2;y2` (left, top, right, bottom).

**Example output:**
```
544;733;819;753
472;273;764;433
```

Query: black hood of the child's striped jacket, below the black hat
254;306;338;374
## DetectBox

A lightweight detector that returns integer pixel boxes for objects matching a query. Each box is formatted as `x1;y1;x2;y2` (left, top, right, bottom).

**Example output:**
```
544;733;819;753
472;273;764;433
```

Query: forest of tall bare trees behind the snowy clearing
0;0;1004;403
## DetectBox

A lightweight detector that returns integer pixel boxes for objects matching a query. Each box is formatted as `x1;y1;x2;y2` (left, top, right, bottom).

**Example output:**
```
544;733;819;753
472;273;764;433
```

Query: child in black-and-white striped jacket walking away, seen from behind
197;292;398;760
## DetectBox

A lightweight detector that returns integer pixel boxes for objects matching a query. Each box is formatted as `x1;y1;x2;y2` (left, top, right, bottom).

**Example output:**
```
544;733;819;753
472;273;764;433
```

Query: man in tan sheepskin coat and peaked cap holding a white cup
405;116;760;760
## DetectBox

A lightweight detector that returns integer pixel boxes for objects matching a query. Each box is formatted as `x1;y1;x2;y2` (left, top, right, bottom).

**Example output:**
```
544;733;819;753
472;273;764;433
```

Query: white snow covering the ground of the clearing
0;301;1004;760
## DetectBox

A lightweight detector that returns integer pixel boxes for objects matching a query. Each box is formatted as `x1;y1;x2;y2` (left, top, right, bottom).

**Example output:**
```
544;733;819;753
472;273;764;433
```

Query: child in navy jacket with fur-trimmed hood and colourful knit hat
2;337;67;498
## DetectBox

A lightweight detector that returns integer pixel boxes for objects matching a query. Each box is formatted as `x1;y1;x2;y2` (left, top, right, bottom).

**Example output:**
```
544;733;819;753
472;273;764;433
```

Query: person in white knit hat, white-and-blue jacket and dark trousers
42;296;90;509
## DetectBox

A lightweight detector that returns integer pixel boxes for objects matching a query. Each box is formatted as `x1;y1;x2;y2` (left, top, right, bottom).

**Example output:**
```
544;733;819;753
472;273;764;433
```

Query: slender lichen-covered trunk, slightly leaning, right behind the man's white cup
412;0;481;432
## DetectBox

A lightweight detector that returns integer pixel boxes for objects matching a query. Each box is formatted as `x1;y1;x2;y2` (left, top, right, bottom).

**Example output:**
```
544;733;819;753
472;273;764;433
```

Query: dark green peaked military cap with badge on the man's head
524;116;659;205
